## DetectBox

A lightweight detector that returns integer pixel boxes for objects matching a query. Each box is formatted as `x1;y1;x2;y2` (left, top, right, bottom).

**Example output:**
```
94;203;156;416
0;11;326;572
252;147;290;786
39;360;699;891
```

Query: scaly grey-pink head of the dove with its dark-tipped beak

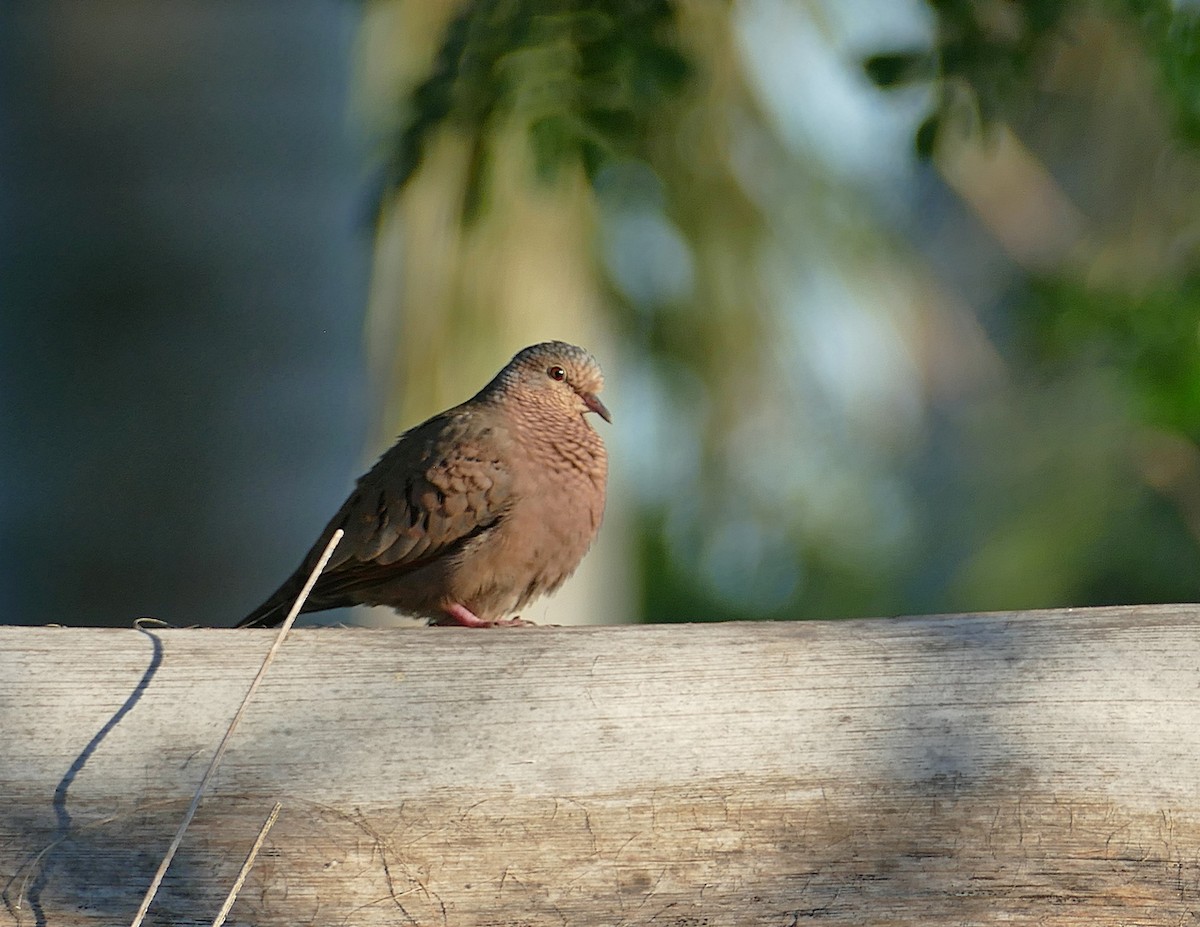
488;341;612;423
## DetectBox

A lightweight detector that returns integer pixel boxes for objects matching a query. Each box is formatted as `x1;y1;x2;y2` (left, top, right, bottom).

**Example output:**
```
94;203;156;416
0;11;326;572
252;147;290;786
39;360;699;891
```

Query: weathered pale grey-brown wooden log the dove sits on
0;606;1200;927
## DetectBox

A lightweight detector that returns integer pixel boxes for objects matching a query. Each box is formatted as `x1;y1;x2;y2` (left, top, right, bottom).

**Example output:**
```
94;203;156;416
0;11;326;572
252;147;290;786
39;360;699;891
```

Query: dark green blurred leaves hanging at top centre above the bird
388;0;688;219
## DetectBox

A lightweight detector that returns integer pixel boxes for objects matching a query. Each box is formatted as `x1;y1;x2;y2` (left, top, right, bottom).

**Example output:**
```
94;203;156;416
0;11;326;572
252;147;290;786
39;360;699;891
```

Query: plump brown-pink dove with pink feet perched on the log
236;341;612;628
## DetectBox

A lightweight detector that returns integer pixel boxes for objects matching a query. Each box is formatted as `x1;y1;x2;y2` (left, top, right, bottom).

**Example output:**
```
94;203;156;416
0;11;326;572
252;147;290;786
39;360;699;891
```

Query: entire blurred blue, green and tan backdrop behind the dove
0;0;1200;626
